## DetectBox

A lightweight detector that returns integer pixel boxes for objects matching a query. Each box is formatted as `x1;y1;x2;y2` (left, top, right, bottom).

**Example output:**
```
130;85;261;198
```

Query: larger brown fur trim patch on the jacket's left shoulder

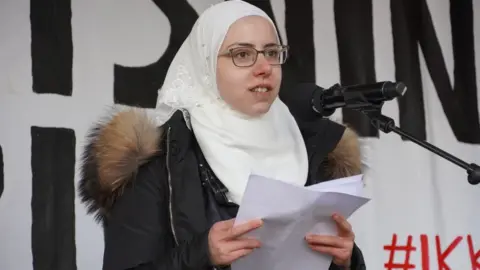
79;106;163;223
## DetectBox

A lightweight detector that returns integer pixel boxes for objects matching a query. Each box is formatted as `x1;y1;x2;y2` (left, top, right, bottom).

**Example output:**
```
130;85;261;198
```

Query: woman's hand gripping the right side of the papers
305;214;355;267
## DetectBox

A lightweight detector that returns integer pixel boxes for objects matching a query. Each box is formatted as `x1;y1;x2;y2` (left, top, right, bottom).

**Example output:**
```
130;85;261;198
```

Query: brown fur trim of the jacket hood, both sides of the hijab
78;108;361;224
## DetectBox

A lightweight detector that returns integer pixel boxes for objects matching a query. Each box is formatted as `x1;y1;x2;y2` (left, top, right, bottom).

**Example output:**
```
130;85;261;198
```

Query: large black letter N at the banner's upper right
390;0;480;144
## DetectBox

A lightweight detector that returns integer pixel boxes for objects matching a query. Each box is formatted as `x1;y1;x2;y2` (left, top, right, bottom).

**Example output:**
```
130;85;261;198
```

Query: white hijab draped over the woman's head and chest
155;0;308;204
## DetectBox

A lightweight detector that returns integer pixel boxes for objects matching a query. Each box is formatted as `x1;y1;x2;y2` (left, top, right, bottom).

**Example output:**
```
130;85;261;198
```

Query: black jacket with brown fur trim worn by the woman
79;110;366;270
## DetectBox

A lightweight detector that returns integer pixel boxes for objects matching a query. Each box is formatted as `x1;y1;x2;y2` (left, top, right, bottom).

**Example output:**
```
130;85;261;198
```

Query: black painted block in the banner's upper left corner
30;0;73;96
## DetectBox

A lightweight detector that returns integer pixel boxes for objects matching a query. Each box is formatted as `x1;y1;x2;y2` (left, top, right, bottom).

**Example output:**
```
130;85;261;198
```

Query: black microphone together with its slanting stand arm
282;81;480;185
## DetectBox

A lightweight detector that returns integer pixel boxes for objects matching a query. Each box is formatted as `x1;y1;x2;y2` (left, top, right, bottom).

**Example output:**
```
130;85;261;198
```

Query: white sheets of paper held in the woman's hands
232;175;370;270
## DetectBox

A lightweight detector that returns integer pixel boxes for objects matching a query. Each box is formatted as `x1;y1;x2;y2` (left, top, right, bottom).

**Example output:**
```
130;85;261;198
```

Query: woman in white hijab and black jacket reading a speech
80;1;365;270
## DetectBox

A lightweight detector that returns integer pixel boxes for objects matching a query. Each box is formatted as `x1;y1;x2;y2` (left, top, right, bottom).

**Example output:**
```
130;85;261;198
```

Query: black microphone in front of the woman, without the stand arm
284;81;407;119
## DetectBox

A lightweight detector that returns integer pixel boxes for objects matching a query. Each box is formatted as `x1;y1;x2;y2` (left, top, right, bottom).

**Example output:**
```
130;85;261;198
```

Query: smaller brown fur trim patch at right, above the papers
326;127;362;179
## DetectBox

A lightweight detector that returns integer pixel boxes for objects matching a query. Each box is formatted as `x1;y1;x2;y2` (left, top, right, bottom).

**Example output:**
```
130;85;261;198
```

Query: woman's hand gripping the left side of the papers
208;219;262;266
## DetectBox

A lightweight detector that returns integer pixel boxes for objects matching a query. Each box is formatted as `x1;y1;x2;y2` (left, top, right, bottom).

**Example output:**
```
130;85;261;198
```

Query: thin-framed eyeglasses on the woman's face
220;45;289;67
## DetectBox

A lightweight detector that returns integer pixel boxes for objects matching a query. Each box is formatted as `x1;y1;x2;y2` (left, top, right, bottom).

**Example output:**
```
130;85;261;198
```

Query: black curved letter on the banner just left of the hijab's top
114;0;198;108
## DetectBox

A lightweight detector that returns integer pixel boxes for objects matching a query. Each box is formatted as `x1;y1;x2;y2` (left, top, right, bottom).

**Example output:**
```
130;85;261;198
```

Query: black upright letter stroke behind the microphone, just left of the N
334;0;378;137
